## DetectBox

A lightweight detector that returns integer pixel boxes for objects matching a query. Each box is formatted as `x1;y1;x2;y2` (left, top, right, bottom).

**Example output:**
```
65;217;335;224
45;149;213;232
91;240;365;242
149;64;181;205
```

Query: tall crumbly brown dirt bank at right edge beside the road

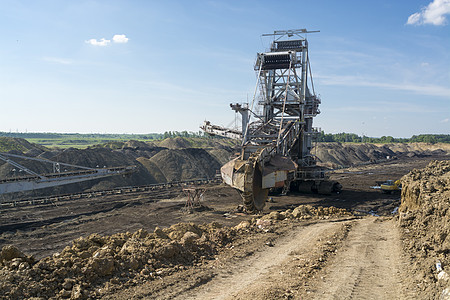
399;160;450;299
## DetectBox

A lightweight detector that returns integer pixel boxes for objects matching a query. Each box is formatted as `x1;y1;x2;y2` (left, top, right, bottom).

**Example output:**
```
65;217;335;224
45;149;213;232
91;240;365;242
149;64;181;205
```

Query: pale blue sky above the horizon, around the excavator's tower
0;0;450;137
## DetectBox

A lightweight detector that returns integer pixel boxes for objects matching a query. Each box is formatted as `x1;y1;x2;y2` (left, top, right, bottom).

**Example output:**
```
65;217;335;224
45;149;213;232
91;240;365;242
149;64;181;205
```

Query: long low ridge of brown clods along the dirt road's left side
0;205;350;299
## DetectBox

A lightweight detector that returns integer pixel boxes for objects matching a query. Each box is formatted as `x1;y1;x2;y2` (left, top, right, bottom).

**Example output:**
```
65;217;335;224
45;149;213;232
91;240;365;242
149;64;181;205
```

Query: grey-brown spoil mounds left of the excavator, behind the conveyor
0;138;234;197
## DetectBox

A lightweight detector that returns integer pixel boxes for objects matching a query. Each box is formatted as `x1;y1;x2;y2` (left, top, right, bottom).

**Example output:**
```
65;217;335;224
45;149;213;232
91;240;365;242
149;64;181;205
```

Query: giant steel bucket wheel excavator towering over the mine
201;29;342;212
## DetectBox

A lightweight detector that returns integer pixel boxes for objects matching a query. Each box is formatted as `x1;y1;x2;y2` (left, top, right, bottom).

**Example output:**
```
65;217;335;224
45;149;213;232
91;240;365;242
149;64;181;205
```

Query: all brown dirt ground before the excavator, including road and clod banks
0;139;450;299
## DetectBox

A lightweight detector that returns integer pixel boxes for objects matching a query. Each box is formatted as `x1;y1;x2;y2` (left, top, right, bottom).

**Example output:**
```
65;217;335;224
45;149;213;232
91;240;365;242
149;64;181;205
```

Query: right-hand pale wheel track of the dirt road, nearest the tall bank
313;218;408;300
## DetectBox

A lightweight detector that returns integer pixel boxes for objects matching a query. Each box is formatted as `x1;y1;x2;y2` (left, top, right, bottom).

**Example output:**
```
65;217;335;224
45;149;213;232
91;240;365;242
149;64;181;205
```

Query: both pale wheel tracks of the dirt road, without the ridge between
176;217;413;299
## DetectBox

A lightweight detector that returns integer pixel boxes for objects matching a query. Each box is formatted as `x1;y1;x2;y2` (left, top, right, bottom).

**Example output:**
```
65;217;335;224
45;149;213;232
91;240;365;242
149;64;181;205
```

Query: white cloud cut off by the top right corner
406;0;450;25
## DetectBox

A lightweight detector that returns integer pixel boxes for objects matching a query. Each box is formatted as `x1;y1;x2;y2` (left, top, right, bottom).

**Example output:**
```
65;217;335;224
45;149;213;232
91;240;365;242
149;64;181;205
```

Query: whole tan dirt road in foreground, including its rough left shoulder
108;216;414;299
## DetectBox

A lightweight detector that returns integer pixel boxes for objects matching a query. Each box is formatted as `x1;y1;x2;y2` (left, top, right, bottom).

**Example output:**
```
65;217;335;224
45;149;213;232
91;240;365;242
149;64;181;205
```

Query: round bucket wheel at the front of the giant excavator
242;160;269;212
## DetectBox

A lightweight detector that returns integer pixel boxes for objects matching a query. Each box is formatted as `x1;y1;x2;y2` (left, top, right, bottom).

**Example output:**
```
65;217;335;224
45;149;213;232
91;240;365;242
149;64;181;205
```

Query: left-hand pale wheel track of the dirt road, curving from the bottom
175;222;341;299
